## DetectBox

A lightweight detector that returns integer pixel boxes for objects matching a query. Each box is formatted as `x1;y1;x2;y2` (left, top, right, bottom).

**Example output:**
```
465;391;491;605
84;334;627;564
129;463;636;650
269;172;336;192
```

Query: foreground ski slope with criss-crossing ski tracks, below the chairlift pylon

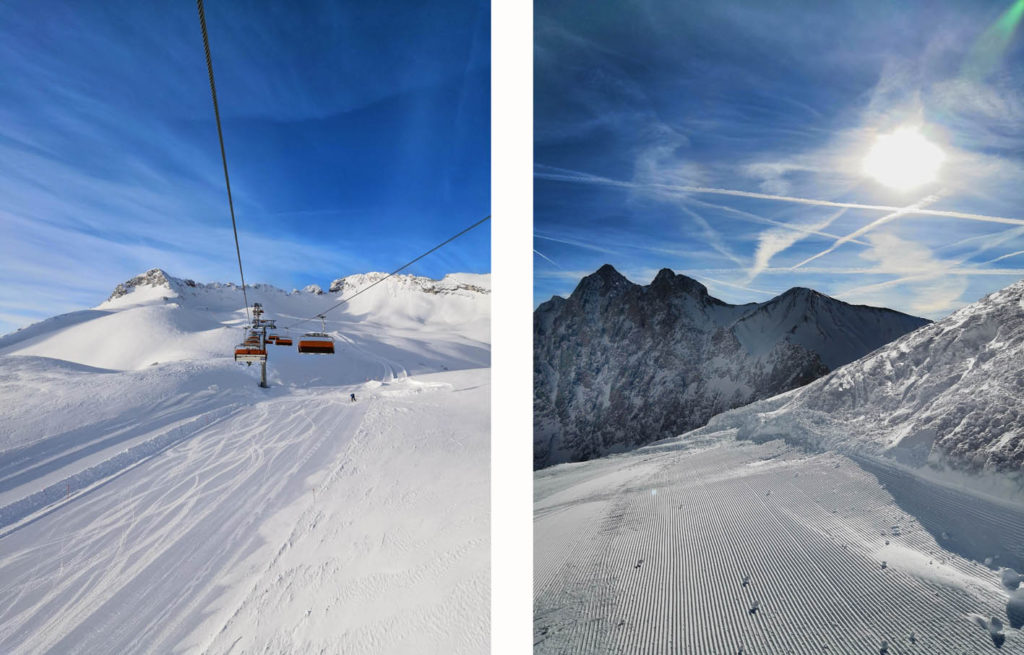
0;369;489;653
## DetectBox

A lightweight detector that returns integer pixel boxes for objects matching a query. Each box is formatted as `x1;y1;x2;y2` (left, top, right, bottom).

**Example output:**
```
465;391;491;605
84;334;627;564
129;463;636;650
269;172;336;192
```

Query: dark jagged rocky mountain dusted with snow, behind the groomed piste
534;266;927;467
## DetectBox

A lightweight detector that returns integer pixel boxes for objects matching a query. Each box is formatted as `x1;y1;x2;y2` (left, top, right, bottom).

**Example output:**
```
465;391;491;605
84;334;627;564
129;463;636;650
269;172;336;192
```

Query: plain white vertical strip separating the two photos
490;0;534;653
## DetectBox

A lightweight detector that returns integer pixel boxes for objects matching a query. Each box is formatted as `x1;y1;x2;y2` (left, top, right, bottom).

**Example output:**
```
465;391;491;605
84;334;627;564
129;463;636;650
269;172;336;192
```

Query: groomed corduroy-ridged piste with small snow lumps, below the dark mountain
534;434;1024;655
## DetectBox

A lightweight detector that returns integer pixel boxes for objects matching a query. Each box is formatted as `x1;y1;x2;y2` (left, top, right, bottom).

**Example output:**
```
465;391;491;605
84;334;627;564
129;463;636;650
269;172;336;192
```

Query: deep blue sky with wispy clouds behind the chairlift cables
0;0;490;334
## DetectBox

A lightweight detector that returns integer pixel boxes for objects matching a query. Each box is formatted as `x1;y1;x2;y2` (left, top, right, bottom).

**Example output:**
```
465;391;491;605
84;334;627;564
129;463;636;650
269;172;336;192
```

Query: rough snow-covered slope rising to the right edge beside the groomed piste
684;281;1024;474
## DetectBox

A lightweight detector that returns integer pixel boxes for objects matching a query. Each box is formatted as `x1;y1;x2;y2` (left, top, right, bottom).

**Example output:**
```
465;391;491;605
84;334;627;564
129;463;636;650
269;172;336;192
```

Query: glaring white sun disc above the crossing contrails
864;127;946;191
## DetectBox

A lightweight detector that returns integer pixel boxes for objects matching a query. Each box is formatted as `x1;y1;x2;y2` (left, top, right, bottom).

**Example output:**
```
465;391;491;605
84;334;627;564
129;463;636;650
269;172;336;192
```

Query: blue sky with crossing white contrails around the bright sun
534;0;1024;318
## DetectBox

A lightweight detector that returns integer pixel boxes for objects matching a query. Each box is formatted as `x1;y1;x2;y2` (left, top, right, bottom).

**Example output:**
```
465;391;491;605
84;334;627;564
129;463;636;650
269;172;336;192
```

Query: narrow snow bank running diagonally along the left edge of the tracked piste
0;404;239;538
